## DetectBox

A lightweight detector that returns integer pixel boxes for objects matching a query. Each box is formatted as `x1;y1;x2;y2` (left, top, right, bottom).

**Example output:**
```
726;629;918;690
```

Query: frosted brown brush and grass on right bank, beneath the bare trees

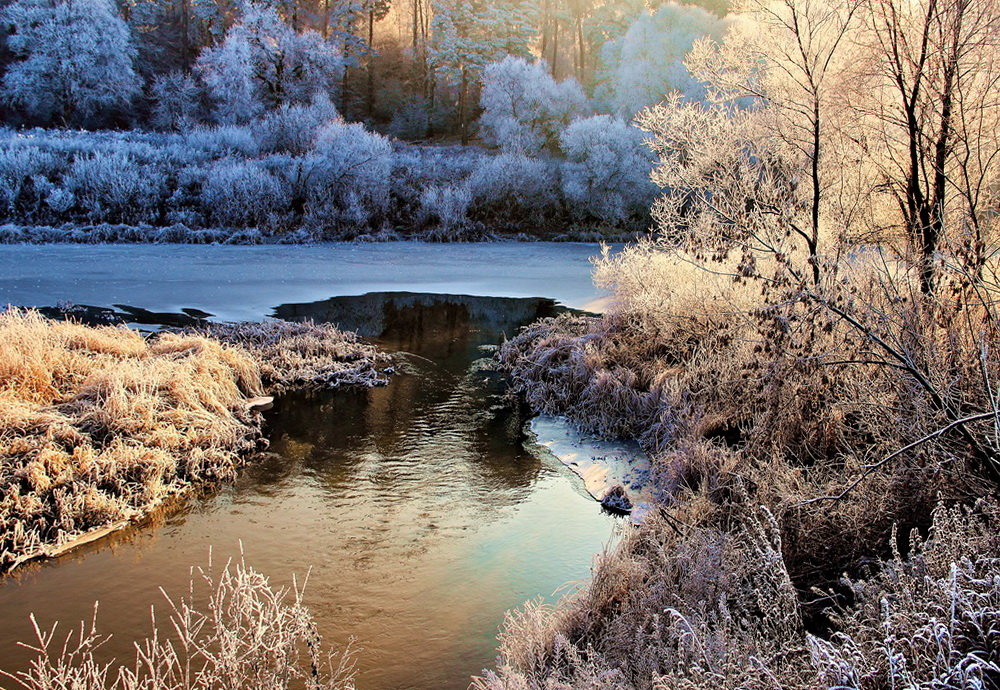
492;241;1000;688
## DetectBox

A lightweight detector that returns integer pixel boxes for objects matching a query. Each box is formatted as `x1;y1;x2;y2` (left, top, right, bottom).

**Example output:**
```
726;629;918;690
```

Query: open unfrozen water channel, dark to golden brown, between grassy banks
0;292;616;688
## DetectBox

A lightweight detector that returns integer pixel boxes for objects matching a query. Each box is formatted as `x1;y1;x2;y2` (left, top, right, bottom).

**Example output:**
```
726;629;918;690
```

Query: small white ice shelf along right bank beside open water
529;415;654;524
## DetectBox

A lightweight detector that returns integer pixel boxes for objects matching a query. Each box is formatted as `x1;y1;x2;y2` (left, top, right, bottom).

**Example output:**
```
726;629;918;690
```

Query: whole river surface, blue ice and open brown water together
0;243;617;689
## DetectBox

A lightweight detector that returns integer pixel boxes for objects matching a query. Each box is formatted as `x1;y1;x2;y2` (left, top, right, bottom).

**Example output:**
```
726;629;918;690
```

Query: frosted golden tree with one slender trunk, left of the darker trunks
640;0;859;284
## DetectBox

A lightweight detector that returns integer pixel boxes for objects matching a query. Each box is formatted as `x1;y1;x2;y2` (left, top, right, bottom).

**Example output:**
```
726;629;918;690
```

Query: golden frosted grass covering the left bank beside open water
0;309;384;570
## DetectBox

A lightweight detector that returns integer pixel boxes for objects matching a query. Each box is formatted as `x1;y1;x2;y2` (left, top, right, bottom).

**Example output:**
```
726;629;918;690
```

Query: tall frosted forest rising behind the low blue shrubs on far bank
0;0;726;134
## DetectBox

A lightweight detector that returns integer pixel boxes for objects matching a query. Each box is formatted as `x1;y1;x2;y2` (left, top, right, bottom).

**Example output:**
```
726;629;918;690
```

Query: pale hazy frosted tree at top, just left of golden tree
594;2;727;119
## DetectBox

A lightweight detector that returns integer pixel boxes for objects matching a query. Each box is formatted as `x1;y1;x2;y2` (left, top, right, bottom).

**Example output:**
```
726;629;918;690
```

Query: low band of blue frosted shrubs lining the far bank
0;121;655;244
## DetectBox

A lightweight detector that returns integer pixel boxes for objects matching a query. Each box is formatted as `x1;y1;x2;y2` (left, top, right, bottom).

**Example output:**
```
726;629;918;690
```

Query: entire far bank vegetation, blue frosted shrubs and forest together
0;0;728;243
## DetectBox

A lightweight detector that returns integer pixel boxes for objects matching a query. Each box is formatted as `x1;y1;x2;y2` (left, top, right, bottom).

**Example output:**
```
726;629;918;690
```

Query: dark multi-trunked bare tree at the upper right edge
854;0;1000;294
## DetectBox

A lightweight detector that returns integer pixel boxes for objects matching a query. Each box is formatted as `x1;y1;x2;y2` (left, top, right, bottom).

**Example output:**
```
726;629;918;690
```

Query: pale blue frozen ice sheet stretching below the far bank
0;242;612;320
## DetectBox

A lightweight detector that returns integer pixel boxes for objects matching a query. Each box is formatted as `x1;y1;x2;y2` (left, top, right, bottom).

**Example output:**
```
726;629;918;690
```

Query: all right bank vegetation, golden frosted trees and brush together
477;0;1000;690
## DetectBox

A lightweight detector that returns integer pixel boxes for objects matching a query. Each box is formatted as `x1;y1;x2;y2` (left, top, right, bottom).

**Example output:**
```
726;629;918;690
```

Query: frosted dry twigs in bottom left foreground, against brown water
0;559;354;690
